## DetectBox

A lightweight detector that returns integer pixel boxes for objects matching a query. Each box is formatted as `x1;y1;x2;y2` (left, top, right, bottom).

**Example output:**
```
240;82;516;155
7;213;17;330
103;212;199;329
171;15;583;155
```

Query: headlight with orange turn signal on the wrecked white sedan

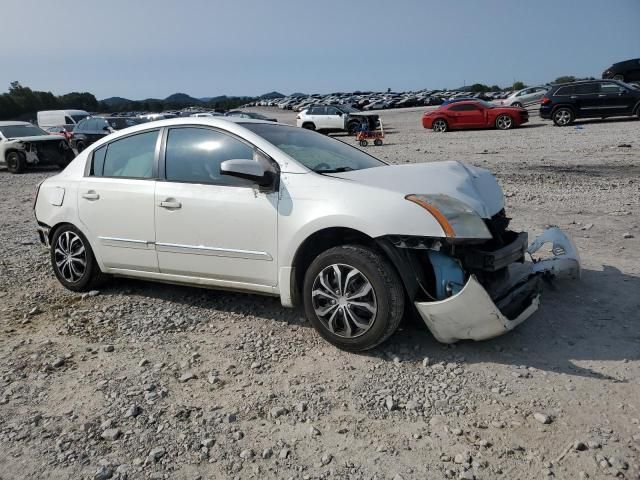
404;194;491;239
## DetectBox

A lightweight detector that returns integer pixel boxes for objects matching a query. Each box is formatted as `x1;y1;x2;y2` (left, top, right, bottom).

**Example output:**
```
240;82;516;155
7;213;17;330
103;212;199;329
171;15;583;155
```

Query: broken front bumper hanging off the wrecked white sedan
415;227;580;343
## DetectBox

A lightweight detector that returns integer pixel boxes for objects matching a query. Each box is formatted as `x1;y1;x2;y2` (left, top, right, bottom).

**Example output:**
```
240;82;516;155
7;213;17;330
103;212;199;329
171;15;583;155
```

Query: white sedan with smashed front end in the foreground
35;118;580;351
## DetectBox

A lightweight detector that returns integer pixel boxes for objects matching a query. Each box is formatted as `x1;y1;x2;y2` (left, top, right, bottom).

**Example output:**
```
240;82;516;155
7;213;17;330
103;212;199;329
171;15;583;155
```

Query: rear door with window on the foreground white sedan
78;130;158;272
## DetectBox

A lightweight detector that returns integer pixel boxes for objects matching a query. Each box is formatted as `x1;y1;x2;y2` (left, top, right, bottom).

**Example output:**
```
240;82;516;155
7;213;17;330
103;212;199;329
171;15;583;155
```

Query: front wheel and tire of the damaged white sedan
303;245;404;352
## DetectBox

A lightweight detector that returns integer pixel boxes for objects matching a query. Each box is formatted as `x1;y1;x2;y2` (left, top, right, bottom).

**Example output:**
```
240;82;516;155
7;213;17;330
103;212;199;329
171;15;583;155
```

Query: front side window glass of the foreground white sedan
165;127;254;187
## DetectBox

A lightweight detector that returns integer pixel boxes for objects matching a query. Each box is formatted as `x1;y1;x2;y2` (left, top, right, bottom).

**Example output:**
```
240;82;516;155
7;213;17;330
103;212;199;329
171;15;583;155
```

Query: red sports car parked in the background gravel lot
422;100;529;132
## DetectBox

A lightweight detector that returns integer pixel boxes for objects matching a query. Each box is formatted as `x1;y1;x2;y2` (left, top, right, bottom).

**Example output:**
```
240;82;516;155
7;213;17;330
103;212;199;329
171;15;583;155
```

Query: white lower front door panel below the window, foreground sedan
151;182;278;286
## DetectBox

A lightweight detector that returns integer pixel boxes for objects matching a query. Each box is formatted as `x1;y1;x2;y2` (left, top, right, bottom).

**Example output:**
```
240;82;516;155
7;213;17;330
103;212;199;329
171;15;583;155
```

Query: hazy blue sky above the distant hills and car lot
0;0;640;99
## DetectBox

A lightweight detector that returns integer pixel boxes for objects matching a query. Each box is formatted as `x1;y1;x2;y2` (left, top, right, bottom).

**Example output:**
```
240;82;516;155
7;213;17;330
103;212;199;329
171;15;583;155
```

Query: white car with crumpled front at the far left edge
0;122;74;173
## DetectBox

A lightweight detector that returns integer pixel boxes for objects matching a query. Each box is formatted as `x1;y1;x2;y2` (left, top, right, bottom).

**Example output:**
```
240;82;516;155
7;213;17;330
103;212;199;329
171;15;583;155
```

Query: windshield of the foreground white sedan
242;123;386;173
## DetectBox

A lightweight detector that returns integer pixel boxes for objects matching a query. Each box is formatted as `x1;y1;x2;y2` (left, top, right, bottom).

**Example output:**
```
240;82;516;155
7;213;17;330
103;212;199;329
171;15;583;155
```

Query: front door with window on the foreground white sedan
155;126;278;288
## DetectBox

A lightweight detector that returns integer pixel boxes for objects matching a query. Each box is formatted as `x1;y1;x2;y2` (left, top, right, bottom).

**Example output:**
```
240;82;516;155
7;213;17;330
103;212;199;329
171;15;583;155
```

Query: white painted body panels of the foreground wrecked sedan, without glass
35;117;579;342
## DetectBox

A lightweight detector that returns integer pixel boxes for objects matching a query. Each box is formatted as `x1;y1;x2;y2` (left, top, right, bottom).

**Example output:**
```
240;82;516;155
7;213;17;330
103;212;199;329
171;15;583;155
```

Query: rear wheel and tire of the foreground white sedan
51;225;104;292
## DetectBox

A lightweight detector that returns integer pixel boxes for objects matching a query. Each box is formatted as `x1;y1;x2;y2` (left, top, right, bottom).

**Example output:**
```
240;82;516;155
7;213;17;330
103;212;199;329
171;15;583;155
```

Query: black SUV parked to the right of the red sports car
540;80;640;127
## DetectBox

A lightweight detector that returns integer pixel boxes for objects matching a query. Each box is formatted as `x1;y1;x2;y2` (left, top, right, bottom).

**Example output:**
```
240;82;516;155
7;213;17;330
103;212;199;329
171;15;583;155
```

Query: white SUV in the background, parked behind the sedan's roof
296;105;378;135
